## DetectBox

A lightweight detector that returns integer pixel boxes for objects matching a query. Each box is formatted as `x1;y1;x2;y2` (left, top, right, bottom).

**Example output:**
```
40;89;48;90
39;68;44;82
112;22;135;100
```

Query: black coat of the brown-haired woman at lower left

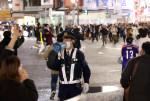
0;79;38;101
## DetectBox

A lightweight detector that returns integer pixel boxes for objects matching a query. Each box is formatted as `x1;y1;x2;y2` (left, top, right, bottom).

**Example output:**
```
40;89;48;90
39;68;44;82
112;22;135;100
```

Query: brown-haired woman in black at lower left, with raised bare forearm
0;26;38;101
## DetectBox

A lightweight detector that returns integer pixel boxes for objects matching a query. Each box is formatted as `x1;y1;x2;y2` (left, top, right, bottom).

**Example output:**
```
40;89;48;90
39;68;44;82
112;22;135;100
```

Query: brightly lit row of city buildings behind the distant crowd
0;0;150;27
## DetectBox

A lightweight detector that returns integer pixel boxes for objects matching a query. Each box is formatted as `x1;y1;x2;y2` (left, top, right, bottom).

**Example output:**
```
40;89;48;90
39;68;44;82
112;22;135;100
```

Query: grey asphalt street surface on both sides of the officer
0;34;124;101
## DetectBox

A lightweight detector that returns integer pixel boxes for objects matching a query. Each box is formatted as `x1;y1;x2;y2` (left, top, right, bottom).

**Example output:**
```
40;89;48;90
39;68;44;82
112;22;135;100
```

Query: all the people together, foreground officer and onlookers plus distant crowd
0;23;150;101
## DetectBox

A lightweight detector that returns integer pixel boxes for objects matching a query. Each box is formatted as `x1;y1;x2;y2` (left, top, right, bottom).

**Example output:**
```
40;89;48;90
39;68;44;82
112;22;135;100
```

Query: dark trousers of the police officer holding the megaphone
59;84;82;101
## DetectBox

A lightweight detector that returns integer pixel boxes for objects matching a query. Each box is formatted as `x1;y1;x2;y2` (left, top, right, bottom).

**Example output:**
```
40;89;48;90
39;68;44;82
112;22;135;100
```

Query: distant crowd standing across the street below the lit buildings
33;23;150;45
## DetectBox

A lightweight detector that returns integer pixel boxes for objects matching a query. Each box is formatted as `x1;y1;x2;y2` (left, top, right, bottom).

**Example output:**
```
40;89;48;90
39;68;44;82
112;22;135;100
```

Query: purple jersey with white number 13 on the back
121;45;139;70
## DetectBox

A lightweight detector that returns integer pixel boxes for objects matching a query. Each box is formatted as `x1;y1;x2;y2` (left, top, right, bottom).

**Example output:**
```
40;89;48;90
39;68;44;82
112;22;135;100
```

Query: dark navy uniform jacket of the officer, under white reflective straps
49;49;91;83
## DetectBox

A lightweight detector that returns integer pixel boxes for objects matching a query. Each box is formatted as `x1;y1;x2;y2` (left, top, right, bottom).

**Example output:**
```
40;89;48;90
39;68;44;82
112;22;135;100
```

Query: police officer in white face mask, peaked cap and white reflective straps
52;32;91;101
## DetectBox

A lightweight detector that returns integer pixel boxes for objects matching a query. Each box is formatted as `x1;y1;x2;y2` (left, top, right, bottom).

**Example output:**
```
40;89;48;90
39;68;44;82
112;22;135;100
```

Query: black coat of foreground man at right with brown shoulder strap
121;55;150;101
